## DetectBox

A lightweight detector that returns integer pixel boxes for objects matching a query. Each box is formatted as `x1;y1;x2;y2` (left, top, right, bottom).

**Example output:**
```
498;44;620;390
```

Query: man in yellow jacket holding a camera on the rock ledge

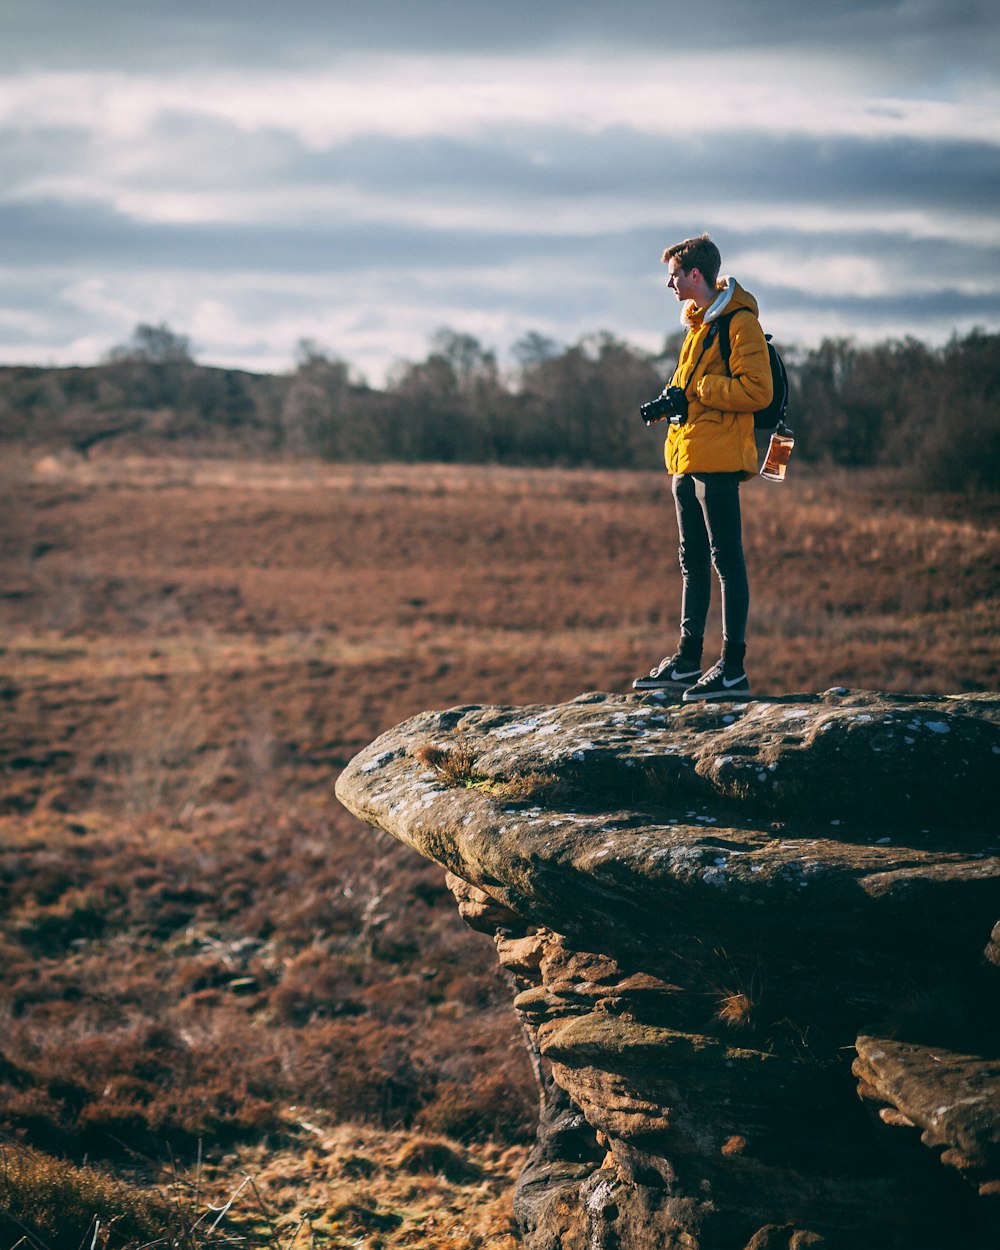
633;234;771;703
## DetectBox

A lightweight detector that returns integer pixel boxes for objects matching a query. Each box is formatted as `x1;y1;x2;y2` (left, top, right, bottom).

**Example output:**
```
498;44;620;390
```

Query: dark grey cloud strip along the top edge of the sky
0;0;998;79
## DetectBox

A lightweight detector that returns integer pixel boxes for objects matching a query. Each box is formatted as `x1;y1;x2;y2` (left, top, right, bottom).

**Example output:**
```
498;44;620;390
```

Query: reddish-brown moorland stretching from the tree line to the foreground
0;454;1000;1250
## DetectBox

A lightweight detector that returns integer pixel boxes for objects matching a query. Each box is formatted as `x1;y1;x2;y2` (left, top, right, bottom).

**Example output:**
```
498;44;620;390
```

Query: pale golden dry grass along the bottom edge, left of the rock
0;1130;526;1250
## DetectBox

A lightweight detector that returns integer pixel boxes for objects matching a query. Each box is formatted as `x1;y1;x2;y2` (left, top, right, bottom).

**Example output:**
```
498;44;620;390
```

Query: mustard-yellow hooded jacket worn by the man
664;278;771;478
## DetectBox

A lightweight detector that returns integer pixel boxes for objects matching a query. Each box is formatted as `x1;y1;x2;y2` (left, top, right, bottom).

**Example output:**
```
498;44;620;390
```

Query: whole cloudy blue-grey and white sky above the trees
0;0;1000;385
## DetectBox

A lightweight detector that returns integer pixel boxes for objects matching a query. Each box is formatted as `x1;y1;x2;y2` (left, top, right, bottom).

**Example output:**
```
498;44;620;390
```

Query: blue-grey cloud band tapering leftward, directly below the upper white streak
284;126;1000;216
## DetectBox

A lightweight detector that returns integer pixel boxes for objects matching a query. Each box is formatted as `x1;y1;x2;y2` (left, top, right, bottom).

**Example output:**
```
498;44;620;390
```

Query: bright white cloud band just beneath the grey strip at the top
0;56;1000;149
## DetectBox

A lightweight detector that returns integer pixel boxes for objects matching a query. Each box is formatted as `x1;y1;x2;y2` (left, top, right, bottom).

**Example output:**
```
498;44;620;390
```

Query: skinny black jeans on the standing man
674;473;750;648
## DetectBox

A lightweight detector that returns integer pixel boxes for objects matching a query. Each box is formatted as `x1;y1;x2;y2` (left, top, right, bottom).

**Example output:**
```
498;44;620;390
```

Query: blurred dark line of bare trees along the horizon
0;325;1000;490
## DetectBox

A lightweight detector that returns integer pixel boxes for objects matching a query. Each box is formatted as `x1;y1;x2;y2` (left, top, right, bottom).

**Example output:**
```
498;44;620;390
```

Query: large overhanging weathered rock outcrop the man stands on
338;690;1000;1250
